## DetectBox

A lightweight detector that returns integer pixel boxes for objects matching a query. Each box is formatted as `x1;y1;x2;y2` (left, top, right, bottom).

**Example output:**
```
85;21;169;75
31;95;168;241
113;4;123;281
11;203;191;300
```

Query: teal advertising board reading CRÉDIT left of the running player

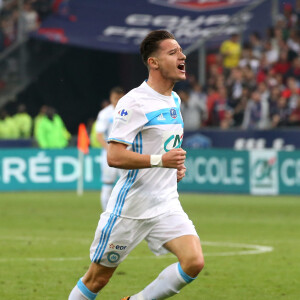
0;148;101;191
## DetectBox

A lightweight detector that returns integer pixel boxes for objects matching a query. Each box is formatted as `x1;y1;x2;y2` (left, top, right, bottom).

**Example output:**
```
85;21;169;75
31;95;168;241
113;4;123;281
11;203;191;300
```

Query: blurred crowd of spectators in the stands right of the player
177;4;300;130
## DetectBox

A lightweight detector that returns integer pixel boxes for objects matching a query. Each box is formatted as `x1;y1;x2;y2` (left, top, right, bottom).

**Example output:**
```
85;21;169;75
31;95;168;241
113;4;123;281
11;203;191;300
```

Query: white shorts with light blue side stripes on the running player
90;211;198;267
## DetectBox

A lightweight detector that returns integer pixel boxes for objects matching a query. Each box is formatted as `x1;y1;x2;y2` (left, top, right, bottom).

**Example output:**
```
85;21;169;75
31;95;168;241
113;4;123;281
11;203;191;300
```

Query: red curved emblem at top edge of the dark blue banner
148;0;253;11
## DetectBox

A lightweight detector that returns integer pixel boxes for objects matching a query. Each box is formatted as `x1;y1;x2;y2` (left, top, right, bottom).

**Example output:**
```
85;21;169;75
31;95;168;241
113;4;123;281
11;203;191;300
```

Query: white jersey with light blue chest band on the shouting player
107;82;183;219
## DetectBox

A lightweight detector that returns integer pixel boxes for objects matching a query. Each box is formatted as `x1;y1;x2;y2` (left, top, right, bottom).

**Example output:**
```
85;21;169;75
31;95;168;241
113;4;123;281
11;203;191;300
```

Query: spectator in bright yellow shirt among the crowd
220;33;242;75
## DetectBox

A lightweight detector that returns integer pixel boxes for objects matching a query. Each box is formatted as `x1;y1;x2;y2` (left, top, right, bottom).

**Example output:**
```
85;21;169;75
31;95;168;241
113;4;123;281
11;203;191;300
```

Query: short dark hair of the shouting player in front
140;30;175;66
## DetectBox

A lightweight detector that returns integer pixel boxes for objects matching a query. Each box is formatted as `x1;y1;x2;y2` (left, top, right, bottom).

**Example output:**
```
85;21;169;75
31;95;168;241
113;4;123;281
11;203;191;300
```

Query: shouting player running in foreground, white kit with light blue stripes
69;30;204;300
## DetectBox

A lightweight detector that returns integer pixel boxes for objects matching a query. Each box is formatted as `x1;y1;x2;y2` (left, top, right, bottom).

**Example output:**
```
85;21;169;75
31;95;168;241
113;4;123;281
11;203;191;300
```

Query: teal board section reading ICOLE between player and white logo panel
179;150;250;194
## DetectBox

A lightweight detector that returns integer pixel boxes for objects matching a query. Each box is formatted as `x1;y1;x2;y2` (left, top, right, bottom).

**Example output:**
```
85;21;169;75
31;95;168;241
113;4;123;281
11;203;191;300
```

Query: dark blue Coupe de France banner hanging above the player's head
34;0;272;53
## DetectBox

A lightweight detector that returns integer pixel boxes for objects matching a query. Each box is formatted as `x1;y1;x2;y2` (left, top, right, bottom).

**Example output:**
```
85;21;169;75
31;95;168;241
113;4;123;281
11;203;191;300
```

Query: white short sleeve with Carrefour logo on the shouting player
108;96;148;145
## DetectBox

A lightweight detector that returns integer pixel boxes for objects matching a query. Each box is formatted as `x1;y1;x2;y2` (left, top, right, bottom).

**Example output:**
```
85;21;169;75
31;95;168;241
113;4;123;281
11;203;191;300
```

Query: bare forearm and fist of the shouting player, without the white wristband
107;142;186;169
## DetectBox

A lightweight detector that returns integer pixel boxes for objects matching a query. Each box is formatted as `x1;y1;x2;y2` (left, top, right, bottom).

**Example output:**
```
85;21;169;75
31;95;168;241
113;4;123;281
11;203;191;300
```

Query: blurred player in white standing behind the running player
96;87;125;211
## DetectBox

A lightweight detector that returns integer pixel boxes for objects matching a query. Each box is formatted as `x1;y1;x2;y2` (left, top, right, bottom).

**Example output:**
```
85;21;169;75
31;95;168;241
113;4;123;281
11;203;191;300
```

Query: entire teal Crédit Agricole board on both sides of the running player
0;148;300;195
